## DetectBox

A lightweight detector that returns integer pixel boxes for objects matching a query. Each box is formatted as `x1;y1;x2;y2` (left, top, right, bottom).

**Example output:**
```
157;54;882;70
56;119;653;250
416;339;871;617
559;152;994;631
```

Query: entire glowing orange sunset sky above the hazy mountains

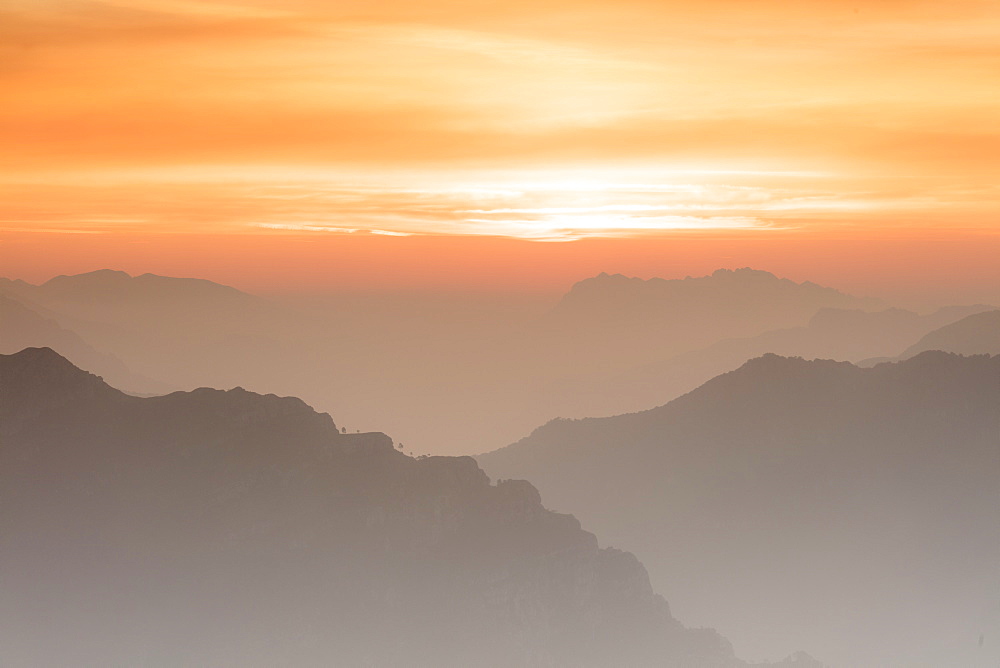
0;0;1000;299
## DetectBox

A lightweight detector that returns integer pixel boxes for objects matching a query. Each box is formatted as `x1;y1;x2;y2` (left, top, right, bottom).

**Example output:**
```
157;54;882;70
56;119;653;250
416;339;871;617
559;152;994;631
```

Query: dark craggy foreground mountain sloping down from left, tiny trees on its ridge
0;348;813;667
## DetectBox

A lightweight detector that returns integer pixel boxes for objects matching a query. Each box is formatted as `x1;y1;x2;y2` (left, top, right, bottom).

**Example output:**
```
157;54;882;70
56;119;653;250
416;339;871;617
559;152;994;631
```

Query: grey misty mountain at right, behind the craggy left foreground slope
478;352;1000;668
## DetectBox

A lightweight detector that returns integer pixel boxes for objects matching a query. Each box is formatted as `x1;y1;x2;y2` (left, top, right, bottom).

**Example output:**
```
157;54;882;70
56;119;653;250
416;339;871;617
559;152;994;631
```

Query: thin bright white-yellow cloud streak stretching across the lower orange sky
0;169;998;240
